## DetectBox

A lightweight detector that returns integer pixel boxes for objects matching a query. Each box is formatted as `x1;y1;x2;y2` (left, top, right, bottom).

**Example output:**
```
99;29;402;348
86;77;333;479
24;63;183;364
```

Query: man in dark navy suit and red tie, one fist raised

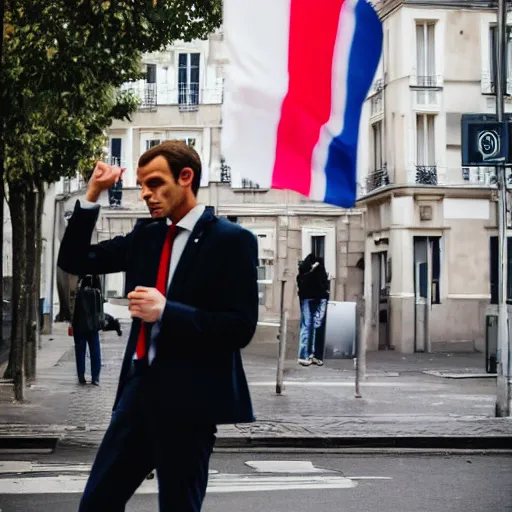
58;141;258;512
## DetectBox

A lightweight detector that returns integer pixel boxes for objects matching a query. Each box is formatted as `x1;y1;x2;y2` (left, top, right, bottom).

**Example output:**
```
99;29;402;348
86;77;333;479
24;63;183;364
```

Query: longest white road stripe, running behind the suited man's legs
0;474;357;495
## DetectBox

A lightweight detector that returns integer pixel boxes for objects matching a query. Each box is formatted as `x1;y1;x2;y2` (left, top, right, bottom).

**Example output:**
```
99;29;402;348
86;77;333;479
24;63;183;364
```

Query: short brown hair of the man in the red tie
139;140;201;195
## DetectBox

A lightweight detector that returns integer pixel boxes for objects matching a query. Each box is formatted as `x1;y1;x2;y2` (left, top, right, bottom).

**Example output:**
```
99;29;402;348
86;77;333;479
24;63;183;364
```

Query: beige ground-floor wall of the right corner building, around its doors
365;187;496;353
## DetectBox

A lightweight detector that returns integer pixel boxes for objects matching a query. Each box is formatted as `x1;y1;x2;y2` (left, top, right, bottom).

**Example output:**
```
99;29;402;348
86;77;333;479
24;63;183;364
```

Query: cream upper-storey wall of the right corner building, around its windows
358;4;512;192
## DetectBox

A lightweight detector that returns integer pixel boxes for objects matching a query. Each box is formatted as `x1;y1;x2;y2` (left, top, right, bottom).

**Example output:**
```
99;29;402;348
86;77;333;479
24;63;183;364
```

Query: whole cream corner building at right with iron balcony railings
358;0;512;352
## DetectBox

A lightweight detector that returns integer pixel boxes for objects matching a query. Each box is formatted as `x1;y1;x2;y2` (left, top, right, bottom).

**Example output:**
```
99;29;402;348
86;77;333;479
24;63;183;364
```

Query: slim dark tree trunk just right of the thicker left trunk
25;188;38;381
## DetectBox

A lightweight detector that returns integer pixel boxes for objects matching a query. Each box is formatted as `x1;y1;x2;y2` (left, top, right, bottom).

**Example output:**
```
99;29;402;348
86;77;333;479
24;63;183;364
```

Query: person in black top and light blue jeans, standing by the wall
297;254;329;366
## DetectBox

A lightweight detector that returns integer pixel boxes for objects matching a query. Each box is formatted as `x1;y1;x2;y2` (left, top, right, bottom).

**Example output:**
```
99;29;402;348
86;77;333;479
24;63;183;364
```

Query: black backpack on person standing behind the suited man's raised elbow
73;276;104;334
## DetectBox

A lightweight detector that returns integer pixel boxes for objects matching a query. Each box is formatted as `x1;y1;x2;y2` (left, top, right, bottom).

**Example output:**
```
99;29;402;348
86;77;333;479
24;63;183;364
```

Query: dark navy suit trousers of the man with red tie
79;370;217;512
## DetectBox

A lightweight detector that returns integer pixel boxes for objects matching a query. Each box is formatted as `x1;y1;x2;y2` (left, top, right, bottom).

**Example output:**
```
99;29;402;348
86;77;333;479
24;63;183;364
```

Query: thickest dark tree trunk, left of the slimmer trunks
5;183;27;401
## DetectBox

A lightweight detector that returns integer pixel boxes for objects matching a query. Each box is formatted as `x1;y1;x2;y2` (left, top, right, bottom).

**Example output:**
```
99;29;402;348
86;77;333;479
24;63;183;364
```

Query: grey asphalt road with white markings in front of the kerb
0;451;512;512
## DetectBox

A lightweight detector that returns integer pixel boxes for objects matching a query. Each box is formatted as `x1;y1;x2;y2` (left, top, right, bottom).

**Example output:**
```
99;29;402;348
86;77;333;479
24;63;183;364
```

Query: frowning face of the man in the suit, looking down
137;156;188;219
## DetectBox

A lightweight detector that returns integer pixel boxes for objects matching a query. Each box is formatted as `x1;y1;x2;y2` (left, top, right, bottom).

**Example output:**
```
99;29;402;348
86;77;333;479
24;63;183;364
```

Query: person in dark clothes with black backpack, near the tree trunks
72;276;103;386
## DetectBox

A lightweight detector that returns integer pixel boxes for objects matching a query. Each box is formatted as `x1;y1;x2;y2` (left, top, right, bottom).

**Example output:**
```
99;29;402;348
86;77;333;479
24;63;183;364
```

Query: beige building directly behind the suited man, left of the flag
47;34;364;357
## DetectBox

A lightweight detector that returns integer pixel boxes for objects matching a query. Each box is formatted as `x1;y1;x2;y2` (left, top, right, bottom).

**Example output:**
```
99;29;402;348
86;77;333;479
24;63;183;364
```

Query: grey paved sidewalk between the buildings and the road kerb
0;324;512;448
